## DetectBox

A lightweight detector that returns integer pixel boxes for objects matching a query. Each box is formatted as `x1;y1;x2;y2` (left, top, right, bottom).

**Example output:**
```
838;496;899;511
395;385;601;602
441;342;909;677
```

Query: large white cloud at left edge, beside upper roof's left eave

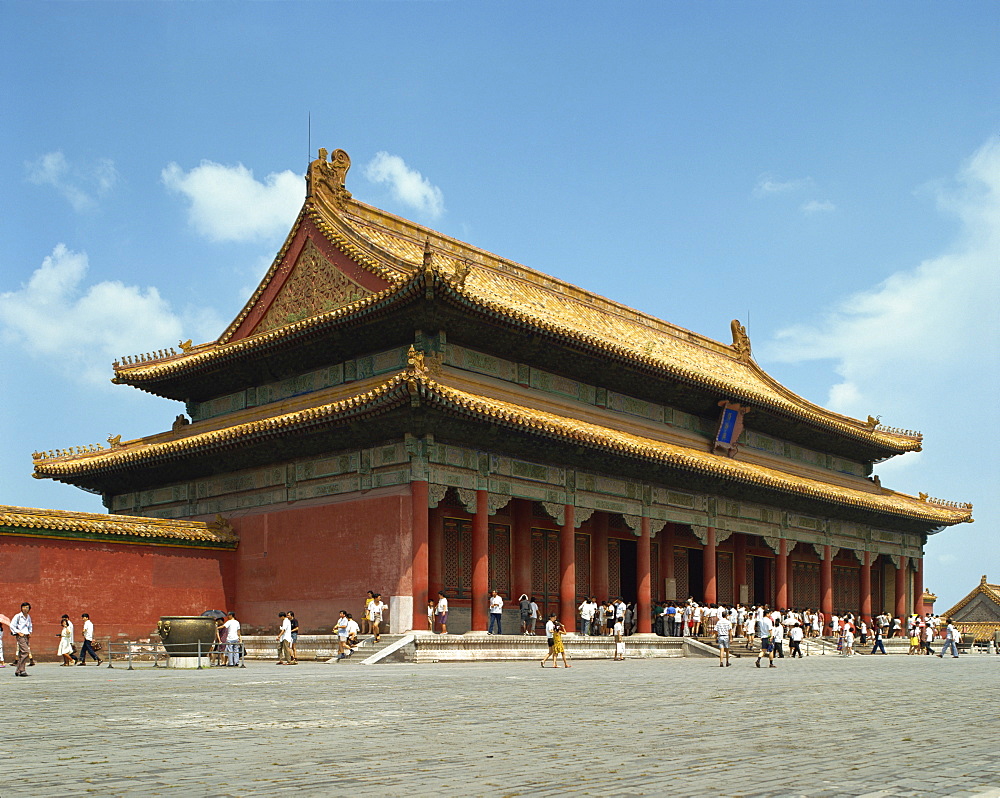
0;244;222;383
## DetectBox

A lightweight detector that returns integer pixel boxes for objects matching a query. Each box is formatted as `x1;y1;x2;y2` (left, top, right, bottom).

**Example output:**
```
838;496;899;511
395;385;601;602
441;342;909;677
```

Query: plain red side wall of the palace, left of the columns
229;488;412;634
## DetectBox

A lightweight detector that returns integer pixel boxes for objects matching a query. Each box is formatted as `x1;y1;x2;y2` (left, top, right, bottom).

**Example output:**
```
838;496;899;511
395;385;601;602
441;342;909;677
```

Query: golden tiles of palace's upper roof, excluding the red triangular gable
114;150;922;453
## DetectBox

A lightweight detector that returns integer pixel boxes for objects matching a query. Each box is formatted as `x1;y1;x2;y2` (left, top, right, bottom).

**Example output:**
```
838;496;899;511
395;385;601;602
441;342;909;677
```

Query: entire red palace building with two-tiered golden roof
25;150;972;632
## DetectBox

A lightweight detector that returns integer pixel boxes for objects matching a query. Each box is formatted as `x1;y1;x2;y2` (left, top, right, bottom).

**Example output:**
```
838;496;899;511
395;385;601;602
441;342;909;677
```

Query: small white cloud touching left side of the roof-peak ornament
160;161;305;241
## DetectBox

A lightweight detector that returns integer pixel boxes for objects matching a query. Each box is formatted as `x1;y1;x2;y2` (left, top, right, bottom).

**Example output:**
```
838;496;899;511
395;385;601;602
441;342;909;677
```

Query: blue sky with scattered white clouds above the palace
0;1;1000;609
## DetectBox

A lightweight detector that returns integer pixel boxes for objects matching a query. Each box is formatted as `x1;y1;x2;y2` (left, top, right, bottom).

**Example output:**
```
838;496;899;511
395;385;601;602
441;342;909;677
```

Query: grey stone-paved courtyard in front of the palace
0;655;1000;798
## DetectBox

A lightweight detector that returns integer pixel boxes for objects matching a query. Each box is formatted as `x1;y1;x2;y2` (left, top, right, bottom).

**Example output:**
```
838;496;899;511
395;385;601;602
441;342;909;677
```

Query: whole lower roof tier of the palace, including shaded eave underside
34;352;972;526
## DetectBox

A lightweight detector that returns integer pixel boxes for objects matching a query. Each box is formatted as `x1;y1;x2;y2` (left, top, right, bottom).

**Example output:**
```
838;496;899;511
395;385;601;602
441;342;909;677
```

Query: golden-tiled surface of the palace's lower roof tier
35;360;972;525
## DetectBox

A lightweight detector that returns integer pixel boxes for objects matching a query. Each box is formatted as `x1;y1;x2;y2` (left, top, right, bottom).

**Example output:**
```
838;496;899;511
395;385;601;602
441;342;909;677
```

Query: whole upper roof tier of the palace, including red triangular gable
114;150;922;459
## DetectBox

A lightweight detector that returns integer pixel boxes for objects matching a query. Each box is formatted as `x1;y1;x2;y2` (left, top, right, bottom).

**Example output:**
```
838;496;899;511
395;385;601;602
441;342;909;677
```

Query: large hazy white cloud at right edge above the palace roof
768;140;1000;424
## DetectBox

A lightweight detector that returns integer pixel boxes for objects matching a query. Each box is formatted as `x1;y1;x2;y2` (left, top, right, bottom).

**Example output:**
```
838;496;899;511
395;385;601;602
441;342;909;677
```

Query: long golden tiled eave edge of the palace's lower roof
35;371;972;526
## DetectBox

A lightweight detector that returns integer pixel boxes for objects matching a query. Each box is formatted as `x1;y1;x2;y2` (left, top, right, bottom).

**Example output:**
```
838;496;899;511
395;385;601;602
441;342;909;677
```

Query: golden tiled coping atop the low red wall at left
0;505;239;549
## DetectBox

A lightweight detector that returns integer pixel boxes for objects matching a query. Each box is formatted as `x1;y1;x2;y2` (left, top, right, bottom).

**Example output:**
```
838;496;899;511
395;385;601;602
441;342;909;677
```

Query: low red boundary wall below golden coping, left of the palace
0;536;235;659
